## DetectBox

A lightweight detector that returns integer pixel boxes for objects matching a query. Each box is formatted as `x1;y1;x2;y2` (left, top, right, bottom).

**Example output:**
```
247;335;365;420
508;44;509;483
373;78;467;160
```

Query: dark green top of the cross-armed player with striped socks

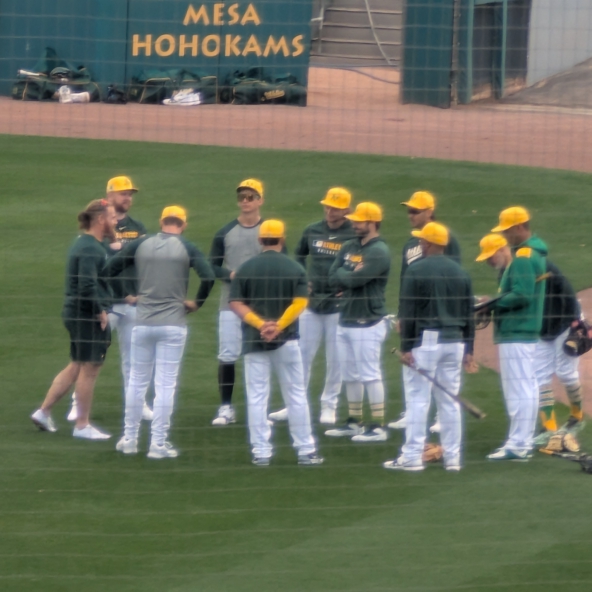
329;237;391;327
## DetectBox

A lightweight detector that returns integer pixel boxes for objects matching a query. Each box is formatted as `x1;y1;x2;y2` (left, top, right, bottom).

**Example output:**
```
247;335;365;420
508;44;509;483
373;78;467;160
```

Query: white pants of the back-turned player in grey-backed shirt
124;325;187;446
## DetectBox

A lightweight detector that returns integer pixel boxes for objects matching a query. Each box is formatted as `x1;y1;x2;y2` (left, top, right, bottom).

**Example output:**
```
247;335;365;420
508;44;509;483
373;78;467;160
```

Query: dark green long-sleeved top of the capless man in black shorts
62;234;111;320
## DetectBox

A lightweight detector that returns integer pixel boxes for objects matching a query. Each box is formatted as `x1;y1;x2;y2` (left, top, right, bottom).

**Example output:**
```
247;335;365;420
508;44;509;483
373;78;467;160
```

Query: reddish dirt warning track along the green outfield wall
0;68;592;172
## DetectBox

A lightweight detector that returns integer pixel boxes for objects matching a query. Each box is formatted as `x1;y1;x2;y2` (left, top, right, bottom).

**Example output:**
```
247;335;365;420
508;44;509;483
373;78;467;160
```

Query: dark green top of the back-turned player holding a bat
399;255;475;354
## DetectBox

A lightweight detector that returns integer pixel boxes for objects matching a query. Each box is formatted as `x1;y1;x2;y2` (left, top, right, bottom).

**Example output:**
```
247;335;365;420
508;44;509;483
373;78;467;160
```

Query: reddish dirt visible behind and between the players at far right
475;288;592;415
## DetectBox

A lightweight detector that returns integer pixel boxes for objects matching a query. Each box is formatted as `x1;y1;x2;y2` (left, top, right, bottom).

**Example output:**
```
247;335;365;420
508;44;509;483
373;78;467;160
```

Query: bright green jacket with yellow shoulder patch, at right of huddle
491;235;547;343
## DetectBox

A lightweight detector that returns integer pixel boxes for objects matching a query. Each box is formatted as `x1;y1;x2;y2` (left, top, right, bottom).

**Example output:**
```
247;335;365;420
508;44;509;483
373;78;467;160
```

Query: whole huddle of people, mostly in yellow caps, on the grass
31;176;583;471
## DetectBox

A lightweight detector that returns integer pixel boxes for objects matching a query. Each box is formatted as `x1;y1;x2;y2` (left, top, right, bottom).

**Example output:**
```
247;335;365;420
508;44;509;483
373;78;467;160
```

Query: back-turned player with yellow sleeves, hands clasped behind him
230;220;323;466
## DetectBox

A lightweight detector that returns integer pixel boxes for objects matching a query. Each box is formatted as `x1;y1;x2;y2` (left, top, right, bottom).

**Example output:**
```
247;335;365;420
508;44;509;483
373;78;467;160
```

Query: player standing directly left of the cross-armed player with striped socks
269;187;355;424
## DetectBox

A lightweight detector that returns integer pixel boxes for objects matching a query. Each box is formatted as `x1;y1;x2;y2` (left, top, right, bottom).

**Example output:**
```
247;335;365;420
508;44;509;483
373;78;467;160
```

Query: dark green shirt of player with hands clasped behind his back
230;250;308;354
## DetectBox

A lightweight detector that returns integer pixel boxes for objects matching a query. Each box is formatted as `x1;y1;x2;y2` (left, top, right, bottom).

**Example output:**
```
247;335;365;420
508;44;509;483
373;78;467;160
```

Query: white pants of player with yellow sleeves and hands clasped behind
245;340;316;458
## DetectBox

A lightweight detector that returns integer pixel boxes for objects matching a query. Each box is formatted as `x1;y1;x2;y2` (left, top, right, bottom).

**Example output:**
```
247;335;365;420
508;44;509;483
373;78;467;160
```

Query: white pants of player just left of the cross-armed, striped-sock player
298;309;341;410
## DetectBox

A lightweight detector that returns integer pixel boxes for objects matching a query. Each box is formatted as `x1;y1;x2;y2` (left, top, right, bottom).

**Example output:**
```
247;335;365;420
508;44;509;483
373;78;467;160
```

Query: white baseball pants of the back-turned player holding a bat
401;340;465;465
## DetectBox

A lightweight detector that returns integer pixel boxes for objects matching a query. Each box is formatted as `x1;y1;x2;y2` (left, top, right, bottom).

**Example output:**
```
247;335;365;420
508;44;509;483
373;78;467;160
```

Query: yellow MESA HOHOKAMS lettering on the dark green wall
130;2;310;59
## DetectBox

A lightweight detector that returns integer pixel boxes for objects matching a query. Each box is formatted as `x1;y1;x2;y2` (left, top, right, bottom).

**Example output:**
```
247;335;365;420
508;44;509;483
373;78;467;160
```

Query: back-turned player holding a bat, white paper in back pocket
383;222;475;471
